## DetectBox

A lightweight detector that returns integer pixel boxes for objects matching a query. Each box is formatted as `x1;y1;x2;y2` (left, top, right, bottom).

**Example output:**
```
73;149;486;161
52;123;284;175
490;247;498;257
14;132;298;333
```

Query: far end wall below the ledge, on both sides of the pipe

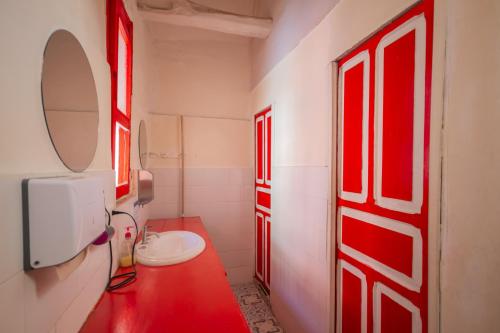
148;115;254;283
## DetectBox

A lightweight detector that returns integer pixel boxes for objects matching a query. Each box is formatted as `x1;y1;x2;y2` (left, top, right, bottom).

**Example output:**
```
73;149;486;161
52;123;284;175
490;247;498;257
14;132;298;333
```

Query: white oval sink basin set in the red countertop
135;231;206;266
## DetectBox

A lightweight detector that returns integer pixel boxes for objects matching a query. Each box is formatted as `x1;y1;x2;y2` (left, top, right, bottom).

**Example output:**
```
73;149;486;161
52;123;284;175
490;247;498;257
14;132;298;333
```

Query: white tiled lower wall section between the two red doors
271;166;330;333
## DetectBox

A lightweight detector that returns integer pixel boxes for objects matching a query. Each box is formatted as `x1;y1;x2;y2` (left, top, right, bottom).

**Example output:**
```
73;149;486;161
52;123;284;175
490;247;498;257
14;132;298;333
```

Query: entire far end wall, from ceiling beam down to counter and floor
144;24;254;283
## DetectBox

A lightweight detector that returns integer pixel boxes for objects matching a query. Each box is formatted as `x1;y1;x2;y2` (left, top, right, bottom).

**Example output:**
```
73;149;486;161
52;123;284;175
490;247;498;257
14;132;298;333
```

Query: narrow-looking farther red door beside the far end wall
255;108;272;289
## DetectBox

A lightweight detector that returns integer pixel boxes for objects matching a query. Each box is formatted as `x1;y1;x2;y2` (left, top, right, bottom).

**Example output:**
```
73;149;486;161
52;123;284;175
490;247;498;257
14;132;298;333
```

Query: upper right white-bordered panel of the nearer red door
374;13;426;214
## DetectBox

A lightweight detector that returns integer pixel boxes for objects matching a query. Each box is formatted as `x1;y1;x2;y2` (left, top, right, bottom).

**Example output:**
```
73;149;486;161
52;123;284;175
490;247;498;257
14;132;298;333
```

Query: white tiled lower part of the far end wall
149;168;254;283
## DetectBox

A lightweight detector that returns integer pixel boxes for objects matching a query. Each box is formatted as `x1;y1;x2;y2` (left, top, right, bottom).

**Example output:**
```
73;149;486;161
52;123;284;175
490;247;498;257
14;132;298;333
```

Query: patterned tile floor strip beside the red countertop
231;283;284;333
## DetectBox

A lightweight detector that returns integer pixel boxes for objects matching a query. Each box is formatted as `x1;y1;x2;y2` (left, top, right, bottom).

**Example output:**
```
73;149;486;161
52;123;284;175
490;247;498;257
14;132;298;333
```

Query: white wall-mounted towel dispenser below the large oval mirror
22;176;106;270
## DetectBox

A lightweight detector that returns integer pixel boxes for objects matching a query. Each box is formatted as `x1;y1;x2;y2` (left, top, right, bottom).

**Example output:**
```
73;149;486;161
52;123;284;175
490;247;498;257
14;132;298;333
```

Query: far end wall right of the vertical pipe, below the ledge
184;118;254;283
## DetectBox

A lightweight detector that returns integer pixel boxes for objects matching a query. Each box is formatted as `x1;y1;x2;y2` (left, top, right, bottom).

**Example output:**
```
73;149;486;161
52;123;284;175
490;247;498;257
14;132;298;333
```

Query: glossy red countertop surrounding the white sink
80;217;250;333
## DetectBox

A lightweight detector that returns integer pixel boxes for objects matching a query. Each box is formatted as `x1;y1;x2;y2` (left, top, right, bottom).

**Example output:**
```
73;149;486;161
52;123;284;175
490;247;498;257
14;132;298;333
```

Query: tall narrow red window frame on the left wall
106;0;133;199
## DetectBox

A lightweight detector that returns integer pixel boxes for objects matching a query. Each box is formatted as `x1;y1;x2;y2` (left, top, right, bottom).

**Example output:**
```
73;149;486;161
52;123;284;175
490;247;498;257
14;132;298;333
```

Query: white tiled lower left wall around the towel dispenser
0;171;147;333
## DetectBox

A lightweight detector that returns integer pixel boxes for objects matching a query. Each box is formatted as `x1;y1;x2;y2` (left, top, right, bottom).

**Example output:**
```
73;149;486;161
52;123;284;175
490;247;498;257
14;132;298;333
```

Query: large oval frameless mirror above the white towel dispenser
42;30;99;172
